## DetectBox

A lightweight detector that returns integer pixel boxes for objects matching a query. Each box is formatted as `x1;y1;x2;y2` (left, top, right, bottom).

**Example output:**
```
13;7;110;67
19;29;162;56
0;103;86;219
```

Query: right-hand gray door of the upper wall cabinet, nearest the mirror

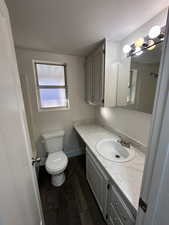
93;45;105;105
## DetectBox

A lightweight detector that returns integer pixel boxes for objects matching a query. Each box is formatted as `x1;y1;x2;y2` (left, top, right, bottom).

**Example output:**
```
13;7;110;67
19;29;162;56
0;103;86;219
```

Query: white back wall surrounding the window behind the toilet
16;49;95;161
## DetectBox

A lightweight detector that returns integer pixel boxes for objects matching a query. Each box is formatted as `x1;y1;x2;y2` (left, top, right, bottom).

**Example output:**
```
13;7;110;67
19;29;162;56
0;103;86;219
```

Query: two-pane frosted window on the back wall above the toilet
35;62;68;109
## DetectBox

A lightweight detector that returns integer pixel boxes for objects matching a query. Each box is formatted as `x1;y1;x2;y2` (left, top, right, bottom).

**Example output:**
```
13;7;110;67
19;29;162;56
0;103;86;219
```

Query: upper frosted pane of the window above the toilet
36;63;65;86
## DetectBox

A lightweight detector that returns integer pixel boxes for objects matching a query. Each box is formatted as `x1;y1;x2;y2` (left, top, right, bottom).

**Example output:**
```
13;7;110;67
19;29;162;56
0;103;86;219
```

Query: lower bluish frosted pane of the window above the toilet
39;88;67;108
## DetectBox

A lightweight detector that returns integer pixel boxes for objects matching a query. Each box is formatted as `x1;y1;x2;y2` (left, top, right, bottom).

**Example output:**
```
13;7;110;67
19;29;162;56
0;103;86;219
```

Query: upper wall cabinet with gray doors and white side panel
85;40;119;107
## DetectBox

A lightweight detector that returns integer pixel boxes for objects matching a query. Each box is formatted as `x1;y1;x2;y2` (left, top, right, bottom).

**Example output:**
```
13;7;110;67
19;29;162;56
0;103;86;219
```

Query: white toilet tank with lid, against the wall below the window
42;130;64;153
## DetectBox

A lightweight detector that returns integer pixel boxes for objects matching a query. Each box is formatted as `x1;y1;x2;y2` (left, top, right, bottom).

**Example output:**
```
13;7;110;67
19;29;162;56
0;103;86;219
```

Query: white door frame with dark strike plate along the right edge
136;11;169;225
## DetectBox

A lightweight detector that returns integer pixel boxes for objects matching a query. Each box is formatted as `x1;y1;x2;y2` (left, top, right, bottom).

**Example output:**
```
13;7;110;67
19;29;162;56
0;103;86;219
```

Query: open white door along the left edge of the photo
0;0;43;225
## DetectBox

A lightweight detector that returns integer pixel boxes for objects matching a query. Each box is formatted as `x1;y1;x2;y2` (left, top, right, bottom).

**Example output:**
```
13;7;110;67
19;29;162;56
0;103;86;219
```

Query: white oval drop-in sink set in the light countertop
96;139;135;163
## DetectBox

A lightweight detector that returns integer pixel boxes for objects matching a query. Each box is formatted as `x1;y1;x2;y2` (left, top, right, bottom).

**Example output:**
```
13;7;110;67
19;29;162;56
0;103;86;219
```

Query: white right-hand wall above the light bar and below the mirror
96;9;167;146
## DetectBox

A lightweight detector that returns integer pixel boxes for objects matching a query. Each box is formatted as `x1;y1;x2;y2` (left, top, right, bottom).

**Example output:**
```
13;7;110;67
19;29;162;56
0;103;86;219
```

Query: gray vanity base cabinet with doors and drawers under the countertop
86;148;136;225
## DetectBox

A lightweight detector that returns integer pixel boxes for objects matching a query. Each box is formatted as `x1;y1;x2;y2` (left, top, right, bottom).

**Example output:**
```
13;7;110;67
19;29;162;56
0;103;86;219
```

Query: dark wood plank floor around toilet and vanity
39;156;106;225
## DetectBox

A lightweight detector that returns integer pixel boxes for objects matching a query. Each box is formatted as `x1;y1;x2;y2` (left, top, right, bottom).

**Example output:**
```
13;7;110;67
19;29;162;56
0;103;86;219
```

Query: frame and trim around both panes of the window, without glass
32;60;70;112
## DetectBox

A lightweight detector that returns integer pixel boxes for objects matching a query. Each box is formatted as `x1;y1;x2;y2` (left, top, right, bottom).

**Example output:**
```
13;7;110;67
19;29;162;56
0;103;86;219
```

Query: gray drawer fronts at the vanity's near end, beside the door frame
110;185;135;225
